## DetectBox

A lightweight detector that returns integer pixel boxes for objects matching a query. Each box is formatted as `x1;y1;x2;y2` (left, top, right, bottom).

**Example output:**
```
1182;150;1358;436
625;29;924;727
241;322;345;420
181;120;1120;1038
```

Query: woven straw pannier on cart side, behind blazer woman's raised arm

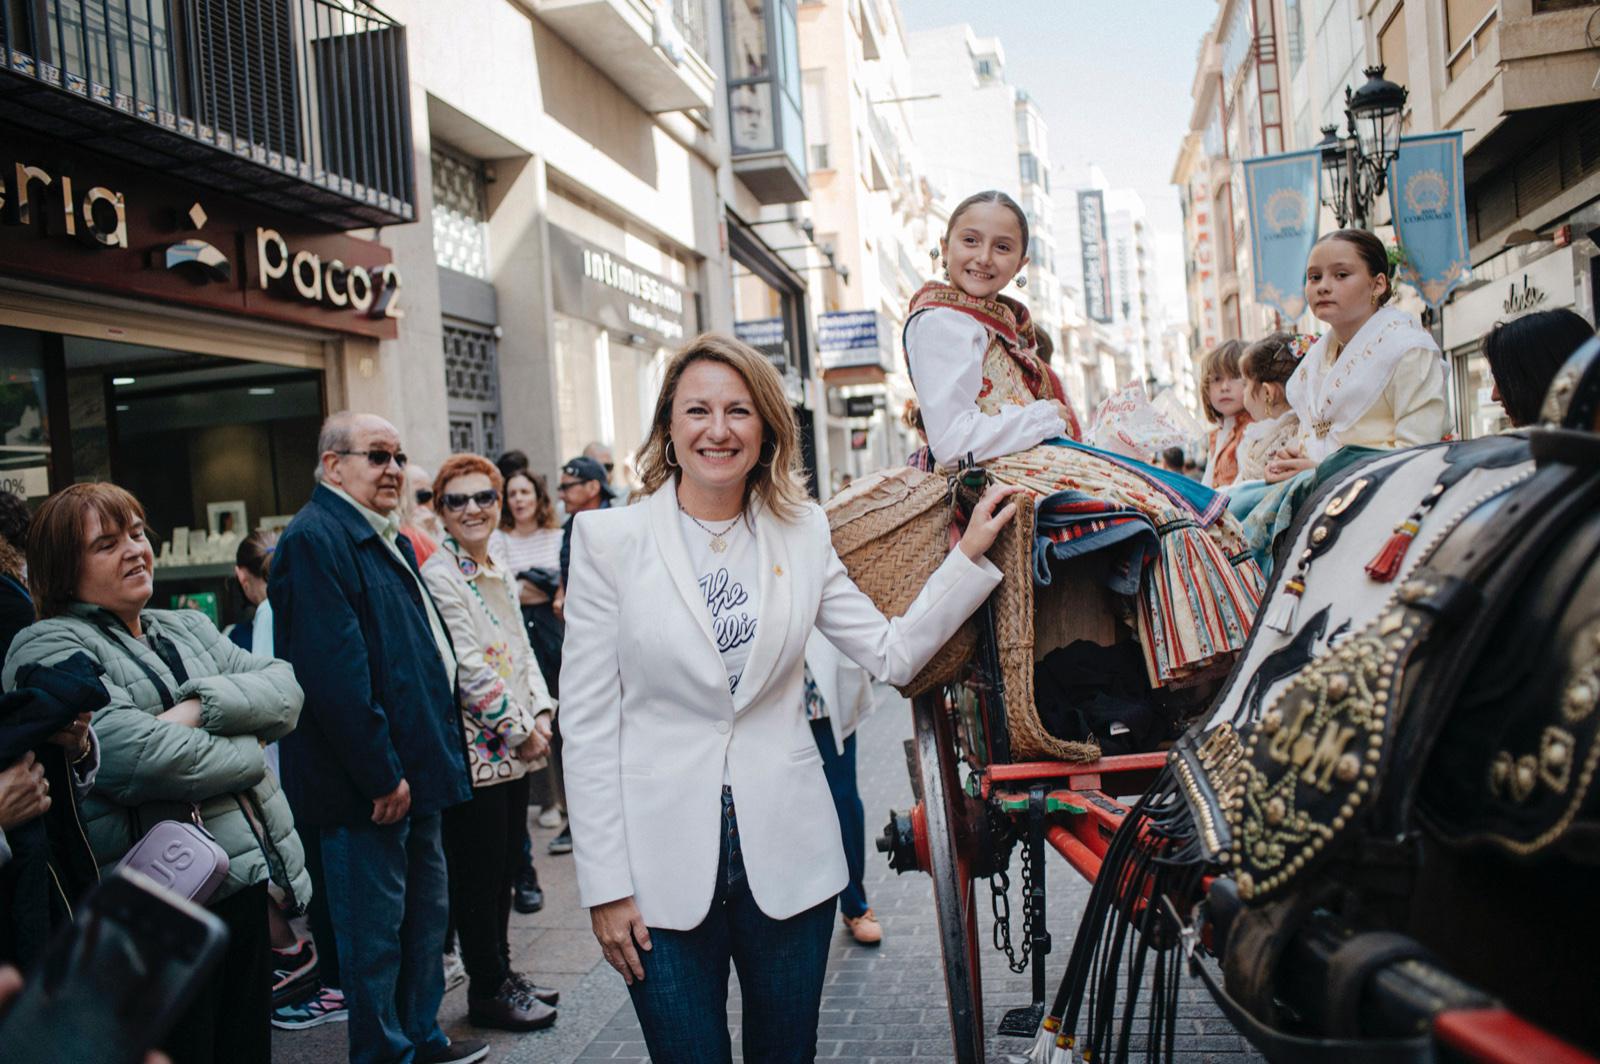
826;467;1099;762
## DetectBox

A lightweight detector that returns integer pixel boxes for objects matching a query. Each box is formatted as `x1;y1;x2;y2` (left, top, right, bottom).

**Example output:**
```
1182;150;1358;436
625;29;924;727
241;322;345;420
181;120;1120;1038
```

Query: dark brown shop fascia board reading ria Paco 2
0;138;405;339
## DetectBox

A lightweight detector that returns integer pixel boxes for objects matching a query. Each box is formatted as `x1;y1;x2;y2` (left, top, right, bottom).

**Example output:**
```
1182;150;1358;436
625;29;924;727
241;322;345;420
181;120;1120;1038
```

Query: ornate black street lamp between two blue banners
1318;64;1410;229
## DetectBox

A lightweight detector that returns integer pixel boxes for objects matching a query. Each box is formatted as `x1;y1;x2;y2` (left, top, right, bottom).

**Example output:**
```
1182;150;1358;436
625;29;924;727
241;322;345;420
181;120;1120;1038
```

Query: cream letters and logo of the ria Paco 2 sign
0;162;405;318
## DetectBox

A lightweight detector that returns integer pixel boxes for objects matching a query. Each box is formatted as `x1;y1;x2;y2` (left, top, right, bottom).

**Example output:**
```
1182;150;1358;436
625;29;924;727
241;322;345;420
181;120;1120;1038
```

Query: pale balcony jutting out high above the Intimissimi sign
531;0;717;114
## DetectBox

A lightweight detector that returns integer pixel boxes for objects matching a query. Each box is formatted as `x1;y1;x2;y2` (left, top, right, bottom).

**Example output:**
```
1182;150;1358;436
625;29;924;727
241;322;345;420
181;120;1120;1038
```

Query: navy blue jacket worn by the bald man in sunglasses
267;485;472;827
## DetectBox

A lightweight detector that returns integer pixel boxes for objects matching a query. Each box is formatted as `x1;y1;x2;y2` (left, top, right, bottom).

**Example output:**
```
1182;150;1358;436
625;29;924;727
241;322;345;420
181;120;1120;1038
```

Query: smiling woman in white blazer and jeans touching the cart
562;334;1016;1064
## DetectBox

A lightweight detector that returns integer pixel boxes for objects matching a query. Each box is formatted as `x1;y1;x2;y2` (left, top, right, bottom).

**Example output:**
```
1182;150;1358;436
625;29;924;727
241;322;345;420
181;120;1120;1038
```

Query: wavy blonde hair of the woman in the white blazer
637;333;810;520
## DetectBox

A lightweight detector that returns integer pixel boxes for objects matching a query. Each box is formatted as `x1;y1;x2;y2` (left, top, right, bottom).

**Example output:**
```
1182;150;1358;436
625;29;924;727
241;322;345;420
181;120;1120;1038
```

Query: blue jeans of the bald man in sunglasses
322;813;450;1064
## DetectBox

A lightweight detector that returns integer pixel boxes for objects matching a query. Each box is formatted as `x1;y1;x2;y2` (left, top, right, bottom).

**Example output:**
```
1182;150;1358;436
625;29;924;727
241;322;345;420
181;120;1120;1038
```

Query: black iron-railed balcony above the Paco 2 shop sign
0;0;416;229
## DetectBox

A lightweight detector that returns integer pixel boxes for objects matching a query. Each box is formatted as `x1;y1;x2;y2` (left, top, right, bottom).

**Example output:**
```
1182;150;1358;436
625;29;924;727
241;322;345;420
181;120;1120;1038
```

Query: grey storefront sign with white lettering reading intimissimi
550;226;699;347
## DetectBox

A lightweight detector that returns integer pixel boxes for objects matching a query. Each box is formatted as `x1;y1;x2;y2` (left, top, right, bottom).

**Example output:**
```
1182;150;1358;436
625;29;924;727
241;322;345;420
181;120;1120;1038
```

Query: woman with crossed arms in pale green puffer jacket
0;483;310;1064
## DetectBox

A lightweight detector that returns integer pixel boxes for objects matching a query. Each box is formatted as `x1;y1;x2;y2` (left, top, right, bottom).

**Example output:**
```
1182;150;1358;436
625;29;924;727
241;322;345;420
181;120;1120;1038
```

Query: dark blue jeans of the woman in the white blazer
629;787;834;1064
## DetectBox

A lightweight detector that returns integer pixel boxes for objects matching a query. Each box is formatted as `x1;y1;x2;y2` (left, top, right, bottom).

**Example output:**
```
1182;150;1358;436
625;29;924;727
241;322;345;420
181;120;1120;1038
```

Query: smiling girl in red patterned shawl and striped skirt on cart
906;192;1261;685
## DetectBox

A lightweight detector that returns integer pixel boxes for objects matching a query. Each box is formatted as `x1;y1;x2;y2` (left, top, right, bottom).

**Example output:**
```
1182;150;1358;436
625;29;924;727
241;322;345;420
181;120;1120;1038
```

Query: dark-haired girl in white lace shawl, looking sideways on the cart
1267;229;1450;477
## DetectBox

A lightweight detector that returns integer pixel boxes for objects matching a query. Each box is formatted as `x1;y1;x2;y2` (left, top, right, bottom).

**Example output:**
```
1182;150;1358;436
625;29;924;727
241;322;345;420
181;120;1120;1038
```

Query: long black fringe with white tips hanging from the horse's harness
1051;770;1205;1064
